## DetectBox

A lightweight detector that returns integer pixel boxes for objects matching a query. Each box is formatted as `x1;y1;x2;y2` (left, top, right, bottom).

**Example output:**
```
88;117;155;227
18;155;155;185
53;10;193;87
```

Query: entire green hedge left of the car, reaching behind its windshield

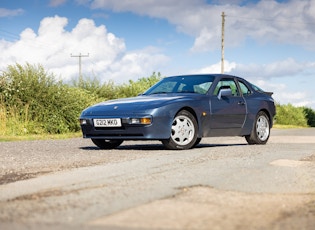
0;63;161;135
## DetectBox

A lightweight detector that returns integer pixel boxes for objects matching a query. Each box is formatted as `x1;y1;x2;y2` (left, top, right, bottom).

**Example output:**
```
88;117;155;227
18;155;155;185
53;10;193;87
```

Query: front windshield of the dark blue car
144;75;215;95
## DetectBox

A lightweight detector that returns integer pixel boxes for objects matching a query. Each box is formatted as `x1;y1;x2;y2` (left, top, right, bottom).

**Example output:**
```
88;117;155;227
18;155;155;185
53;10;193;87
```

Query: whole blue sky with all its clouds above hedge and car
0;0;315;109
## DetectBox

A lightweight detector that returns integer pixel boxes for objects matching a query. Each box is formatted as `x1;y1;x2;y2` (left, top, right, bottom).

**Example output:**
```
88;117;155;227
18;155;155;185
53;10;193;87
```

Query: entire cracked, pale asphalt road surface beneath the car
0;128;315;230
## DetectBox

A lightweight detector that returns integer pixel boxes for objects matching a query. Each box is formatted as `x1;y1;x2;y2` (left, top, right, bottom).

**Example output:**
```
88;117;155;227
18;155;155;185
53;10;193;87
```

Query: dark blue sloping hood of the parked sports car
82;95;192;116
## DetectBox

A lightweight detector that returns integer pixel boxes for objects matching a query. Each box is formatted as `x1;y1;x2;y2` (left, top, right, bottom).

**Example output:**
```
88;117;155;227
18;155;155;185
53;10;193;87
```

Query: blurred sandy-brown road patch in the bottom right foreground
90;187;315;230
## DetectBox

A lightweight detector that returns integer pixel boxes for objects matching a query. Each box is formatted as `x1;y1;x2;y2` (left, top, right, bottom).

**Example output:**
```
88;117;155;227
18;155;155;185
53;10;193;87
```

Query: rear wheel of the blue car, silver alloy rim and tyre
245;111;270;145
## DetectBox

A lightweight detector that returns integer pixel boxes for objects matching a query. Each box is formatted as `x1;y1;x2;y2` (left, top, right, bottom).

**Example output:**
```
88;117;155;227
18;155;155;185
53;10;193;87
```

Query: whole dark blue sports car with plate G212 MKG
80;74;276;150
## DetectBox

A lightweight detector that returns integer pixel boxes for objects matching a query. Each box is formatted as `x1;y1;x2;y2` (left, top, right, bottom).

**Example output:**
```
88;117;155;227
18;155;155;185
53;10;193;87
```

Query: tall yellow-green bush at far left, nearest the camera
0;64;96;135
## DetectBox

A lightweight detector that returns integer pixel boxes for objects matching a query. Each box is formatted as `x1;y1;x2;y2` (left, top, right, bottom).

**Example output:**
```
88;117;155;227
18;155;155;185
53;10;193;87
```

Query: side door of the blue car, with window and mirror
210;78;246;132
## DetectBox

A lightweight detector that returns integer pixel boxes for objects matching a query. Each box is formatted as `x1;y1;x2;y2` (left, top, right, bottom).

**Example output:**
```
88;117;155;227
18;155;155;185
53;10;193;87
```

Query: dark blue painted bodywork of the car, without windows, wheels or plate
80;74;276;146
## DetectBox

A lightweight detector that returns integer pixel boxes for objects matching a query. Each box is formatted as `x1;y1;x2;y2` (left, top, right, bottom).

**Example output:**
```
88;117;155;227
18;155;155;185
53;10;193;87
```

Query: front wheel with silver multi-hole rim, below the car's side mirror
162;110;198;150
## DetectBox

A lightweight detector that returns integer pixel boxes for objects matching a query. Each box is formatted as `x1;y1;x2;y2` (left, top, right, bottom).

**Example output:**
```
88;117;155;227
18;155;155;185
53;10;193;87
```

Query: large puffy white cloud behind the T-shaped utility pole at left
0;16;168;82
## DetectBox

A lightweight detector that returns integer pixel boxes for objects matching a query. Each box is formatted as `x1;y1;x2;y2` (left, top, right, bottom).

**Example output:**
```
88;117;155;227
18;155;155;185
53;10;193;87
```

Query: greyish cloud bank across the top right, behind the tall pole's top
86;0;315;52
